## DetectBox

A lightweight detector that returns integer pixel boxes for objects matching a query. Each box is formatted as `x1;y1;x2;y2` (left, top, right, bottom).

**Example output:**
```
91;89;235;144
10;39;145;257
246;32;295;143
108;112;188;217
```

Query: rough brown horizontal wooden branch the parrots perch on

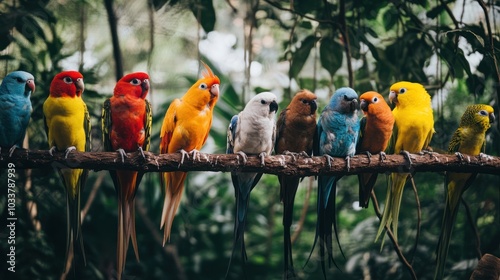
0;149;500;176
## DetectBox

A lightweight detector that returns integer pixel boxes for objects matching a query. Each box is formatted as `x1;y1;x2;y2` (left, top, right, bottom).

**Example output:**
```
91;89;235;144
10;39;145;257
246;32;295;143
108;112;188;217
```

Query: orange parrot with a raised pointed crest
160;62;220;245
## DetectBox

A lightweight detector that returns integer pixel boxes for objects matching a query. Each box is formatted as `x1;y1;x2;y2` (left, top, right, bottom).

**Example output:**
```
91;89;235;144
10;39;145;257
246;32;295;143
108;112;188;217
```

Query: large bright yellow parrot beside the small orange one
376;81;434;241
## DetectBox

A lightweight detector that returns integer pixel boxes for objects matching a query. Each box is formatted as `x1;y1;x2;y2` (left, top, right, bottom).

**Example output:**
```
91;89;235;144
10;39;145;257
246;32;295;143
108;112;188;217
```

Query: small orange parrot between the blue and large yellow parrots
356;91;394;208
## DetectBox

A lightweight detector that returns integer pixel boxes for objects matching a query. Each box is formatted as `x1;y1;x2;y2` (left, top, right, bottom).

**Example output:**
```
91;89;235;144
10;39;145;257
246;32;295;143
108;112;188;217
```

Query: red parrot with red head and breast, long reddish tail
102;72;153;279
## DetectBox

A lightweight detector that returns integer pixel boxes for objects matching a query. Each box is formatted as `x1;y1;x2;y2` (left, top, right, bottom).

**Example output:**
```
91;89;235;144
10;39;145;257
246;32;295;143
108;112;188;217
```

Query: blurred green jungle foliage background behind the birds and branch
0;0;500;279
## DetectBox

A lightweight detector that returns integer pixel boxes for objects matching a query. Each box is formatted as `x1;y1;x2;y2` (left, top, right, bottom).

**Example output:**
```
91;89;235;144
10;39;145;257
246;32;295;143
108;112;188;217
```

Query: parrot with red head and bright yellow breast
43;71;90;272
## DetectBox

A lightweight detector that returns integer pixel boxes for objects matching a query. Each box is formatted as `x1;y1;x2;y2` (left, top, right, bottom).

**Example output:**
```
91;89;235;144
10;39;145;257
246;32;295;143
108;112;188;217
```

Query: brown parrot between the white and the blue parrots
274;90;318;279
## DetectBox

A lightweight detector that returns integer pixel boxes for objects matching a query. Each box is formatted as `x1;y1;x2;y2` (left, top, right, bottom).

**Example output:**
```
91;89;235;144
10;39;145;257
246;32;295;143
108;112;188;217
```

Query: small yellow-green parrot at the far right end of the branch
434;104;495;279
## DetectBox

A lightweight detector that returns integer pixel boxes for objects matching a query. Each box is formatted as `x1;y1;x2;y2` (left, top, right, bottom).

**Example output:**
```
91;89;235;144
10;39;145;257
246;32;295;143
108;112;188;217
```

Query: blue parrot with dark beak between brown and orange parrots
309;87;359;278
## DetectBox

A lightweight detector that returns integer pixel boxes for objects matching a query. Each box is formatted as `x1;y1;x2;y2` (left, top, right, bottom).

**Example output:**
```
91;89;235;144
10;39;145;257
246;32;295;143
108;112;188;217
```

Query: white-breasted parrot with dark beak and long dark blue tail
226;92;278;277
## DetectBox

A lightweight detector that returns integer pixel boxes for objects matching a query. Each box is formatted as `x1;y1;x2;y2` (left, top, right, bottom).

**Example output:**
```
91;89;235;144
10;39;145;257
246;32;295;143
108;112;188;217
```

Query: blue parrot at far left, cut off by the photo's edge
0;71;35;156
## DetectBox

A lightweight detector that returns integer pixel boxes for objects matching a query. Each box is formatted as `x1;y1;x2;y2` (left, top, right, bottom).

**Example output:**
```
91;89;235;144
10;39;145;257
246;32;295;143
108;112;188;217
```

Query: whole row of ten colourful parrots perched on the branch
0;63;495;279
